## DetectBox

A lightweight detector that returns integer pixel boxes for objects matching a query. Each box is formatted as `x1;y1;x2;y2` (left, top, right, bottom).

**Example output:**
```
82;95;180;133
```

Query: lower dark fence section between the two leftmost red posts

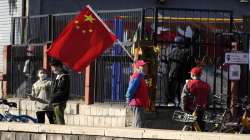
8;45;43;97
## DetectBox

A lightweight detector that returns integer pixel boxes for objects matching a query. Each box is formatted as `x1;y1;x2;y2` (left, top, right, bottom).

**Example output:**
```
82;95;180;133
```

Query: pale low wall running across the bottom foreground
0;123;250;140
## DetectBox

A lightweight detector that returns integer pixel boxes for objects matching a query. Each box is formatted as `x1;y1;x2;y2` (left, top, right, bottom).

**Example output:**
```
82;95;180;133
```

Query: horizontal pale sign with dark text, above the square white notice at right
225;52;249;64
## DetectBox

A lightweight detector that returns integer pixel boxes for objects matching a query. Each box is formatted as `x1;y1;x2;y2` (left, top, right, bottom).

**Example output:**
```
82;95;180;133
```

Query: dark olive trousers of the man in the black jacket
52;102;66;124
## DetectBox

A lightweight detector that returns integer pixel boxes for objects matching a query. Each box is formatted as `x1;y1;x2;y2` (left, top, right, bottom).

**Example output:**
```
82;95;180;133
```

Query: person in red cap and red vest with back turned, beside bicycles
181;67;211;131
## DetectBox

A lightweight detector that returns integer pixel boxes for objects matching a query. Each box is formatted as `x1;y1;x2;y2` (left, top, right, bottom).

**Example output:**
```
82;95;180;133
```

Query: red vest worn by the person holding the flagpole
129;73;149;108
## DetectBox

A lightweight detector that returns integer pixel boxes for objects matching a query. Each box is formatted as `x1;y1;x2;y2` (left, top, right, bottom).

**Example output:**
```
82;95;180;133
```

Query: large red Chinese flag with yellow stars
47;5;116;72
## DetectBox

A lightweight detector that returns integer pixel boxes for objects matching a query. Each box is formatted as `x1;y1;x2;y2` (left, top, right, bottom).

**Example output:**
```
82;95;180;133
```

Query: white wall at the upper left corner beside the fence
0;0;22;72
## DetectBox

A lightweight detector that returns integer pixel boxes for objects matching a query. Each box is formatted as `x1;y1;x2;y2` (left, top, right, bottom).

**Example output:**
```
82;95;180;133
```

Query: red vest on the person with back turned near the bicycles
187;80;210;110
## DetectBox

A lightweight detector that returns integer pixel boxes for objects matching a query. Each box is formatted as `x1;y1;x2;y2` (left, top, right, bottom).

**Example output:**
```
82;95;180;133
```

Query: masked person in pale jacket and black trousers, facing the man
28;69;54;124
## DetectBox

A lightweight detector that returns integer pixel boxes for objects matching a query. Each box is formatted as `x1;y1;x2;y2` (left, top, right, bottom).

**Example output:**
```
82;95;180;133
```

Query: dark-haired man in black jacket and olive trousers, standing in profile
50;59;70;124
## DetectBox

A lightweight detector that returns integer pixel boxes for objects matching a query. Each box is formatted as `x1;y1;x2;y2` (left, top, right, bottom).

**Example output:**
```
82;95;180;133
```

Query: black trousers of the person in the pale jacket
36;111;54;124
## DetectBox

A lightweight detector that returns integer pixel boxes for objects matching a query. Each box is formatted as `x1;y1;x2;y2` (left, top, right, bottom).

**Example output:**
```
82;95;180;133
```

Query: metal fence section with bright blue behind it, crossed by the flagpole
94;9;143;102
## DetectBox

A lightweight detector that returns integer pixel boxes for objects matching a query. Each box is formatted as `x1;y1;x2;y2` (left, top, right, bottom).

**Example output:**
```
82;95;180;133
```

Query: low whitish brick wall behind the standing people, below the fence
0;98;131;127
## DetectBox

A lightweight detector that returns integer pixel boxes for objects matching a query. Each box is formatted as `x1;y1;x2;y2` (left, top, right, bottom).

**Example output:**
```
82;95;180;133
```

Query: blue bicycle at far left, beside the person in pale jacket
0;99;37;123
